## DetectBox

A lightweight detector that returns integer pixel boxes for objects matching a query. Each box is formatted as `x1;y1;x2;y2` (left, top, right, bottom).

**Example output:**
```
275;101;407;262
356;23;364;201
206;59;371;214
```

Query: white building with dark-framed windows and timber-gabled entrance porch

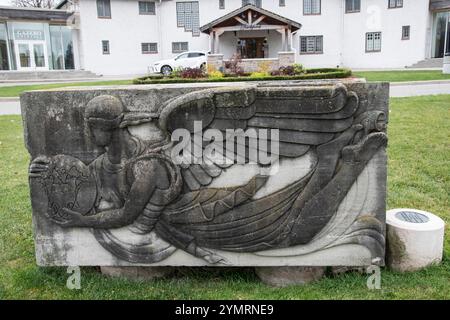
0;0;450;75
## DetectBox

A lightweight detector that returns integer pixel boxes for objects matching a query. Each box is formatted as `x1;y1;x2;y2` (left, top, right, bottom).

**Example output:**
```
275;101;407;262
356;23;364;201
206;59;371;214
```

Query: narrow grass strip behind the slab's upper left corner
0;80;133;97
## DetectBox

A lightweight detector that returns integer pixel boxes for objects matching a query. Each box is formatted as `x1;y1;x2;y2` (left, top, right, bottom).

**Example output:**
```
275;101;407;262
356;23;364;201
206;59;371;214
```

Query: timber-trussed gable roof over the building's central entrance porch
200;4;302;34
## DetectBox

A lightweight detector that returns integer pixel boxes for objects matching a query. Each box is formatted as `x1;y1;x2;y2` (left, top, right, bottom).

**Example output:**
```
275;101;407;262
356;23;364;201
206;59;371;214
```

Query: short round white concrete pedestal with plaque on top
386;209;445;272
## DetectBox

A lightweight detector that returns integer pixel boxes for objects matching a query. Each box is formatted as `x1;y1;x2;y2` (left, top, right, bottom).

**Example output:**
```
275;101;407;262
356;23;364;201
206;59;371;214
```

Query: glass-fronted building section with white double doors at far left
0;7;80;71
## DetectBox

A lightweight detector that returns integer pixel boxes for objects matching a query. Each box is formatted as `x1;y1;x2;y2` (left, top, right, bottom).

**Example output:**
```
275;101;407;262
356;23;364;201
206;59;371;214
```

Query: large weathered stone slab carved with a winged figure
21;80;388;267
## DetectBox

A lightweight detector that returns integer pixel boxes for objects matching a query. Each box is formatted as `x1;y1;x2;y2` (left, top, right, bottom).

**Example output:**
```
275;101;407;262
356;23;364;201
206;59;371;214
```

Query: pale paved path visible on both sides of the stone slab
0;81;450;115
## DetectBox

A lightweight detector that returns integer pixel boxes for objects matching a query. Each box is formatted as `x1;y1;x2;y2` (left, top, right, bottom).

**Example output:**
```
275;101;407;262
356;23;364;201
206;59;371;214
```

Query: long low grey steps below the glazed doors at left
0;70;100;82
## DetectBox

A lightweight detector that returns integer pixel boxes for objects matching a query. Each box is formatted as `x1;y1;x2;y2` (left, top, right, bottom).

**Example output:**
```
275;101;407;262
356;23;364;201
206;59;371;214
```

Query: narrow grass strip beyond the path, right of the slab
353;70;450;82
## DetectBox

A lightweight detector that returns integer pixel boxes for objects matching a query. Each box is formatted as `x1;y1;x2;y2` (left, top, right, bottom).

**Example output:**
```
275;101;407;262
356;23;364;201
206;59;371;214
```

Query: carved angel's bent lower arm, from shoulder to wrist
57;160;159;229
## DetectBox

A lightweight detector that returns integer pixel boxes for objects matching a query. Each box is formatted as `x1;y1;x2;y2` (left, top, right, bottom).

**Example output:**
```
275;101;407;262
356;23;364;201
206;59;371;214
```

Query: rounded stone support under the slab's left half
100;267;175;281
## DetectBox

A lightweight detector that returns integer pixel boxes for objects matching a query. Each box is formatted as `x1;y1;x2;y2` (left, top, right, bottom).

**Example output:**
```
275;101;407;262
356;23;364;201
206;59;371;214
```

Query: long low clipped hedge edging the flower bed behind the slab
133;68;352;84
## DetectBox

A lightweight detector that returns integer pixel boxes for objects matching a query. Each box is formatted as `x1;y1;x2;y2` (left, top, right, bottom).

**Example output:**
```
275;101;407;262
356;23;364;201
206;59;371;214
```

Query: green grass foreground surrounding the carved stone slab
0;95;450;299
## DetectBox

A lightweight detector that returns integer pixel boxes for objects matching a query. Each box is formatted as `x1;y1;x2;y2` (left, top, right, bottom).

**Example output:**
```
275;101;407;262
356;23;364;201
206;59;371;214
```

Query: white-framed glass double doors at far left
15;41;48;70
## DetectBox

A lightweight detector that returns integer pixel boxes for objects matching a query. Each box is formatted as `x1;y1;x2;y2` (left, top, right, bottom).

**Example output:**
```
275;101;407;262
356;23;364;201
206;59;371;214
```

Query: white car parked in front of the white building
150;51;206;75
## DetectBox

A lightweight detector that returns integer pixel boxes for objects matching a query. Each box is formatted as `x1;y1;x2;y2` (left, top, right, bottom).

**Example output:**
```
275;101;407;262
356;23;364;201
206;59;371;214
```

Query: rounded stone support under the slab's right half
255;267;325;287
